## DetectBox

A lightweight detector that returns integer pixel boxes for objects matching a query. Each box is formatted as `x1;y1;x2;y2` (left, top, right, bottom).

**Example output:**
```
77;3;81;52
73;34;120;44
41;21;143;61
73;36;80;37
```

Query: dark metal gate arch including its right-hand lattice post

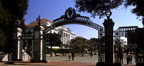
44;7;105;62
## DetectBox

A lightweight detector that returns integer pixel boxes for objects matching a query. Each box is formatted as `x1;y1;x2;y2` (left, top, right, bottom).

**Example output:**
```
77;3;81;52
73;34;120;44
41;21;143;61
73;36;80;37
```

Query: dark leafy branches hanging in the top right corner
125;0;144;23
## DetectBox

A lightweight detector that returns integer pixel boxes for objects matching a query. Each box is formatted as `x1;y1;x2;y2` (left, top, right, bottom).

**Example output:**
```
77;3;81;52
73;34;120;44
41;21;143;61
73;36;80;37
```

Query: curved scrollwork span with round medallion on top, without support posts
45;8;103;36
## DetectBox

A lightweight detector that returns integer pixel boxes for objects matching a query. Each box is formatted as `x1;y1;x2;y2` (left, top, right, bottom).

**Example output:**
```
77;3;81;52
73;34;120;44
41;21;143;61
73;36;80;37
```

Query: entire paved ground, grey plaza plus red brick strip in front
0;55;135;66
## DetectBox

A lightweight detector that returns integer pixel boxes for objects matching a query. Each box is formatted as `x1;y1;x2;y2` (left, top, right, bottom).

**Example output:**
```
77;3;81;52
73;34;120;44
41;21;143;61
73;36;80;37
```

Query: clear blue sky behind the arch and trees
25;0;142;39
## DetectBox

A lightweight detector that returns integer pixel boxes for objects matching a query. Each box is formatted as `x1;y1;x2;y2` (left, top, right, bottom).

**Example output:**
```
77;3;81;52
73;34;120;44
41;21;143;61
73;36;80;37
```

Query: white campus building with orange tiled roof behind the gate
26;18;75;44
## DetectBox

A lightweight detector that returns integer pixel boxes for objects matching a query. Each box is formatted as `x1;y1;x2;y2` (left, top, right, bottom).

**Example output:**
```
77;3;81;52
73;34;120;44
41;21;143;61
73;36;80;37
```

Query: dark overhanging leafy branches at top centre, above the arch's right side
75;0;123;17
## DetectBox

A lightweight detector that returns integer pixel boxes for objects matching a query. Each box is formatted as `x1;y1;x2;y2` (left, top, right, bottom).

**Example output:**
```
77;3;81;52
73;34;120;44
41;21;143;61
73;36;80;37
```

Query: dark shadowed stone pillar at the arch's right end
103;19;114;65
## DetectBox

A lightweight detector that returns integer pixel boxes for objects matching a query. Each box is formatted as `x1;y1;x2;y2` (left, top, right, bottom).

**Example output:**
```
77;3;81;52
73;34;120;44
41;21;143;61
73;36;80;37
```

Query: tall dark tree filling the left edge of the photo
0;0;28;53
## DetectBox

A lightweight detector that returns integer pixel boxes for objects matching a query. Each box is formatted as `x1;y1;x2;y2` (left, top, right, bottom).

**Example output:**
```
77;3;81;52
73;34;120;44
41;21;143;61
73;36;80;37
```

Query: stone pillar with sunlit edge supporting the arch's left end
31;26;46;62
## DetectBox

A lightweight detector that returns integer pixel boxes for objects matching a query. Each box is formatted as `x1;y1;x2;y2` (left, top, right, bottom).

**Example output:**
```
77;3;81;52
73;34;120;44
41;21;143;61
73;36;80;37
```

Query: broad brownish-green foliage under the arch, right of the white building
69;37;99;56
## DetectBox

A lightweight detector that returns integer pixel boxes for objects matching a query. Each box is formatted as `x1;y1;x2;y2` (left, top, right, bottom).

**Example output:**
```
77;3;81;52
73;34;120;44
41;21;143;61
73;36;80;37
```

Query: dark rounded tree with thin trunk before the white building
46;33;62;56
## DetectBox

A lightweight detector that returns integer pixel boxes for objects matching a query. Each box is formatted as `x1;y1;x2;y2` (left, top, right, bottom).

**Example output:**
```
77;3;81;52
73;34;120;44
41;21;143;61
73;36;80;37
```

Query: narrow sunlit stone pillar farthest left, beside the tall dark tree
12;28;22;61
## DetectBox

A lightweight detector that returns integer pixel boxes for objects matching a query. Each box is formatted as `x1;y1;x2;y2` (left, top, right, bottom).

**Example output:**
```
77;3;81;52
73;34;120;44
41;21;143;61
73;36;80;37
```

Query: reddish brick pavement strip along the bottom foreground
0;62;135;66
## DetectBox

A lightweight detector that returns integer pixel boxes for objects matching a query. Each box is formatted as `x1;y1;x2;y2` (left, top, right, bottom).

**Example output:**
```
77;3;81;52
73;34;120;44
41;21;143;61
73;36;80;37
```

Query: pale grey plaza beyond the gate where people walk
47;54;135;65
